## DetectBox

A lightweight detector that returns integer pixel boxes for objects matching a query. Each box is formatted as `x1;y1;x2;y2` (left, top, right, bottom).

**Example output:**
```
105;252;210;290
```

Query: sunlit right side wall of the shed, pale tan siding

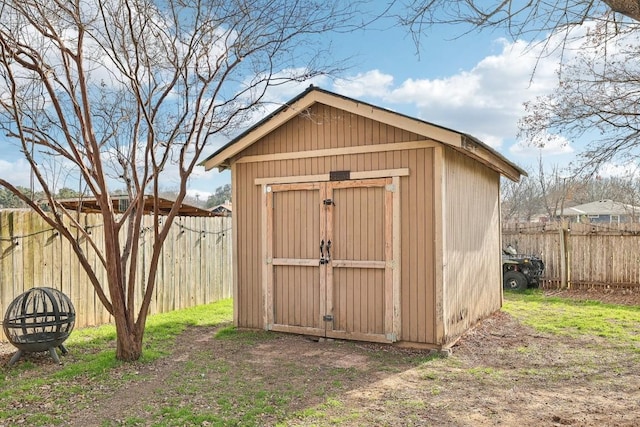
442;149;502;344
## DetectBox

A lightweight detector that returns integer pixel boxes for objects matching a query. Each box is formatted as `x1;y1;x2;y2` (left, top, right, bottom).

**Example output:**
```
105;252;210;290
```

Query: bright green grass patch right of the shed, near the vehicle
504;291;640;351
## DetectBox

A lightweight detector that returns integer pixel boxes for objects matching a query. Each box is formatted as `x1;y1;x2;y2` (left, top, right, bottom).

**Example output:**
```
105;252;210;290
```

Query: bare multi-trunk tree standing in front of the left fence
0;0;368;361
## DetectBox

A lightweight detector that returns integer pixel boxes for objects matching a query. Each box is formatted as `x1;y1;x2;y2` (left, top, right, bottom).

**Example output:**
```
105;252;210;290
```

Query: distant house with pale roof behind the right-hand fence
556;200;640;224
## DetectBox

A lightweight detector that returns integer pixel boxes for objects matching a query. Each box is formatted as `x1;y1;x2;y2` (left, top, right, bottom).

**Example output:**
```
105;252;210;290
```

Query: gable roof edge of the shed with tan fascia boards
201;86;527;181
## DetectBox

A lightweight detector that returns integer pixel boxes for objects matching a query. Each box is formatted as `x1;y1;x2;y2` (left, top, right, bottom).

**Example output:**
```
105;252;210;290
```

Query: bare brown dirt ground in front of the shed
0;290;640;427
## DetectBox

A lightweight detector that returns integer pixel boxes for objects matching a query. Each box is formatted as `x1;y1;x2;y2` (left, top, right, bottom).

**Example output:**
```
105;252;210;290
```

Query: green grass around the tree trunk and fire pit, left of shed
0;300;233;426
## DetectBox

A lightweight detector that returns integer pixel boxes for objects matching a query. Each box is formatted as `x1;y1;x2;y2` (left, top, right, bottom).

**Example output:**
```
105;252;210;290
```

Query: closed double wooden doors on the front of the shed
265;178;395;342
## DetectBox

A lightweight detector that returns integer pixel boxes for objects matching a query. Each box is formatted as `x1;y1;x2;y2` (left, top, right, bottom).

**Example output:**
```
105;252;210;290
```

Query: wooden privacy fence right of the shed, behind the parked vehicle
502;222;640;290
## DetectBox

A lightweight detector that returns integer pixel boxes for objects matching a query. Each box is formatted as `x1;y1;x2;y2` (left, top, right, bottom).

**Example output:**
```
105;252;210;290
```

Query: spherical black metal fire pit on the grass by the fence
2;287;76;366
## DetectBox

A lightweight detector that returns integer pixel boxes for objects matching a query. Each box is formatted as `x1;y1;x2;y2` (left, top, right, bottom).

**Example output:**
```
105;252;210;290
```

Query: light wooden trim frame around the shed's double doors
255;168;402;342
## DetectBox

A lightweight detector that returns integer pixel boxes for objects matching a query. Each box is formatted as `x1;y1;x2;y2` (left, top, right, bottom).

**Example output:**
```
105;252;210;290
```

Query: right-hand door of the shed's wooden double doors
327;180;390;341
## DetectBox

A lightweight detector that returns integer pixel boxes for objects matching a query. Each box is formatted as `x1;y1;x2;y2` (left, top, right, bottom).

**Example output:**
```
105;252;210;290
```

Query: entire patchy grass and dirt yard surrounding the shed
0;292;640;427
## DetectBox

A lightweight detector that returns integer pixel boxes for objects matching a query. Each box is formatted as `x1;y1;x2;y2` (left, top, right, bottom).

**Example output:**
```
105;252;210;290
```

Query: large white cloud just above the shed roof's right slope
334;40;558;154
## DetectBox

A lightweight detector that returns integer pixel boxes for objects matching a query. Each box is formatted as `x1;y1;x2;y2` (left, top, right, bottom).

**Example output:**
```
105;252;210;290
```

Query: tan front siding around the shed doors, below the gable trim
234;149;435;343
